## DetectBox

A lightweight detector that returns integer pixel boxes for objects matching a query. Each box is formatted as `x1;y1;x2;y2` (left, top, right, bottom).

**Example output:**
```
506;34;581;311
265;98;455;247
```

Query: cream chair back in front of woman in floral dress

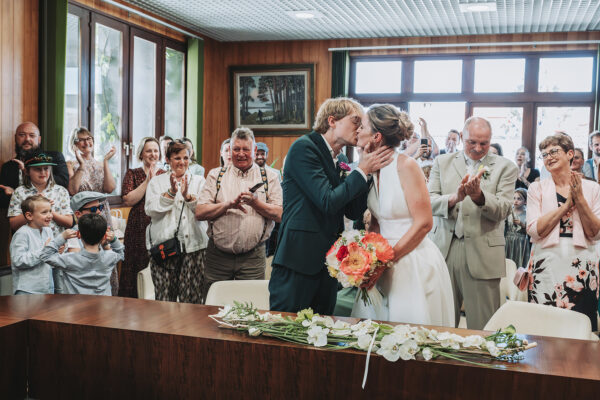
483;300;597;340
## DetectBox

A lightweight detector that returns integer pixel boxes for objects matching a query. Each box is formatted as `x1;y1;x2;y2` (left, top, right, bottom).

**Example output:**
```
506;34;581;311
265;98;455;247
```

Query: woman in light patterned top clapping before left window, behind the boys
67;127;118;230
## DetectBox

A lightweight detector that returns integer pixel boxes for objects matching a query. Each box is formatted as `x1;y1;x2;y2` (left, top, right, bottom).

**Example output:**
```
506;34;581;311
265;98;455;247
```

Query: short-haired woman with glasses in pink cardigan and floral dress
527;134;600;331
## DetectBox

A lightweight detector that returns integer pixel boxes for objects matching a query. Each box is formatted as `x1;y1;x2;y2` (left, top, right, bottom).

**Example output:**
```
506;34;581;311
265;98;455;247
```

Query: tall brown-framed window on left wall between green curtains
63;4;186;200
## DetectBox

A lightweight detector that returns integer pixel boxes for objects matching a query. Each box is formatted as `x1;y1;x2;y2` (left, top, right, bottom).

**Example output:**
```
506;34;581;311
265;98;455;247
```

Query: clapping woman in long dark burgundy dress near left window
119;137;165;297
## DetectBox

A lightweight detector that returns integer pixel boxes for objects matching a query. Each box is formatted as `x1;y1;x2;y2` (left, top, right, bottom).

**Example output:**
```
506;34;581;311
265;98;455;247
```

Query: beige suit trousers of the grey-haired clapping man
446;236;500;329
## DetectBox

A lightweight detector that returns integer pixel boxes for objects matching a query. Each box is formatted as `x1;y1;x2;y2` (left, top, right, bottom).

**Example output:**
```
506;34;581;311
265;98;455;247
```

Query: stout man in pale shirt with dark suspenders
196;128;283;298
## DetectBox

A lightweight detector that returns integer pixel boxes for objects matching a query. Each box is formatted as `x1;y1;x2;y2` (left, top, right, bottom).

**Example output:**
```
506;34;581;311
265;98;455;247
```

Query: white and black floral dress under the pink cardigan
528;193;600;331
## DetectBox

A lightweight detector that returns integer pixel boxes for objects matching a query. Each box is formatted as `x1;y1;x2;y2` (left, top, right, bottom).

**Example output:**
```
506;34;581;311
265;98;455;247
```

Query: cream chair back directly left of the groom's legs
205;280;269;310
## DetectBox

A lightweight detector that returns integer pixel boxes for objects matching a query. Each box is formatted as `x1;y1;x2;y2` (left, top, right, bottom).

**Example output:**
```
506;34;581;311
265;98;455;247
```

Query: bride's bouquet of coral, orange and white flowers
325;230;394;305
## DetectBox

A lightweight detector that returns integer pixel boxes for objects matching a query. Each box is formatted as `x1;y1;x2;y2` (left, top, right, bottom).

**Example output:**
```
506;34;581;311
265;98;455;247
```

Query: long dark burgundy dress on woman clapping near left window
119;167;165;297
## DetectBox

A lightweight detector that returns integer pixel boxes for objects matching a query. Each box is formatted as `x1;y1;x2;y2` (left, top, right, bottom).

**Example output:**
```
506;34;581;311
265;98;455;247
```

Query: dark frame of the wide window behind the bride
349;50;598;165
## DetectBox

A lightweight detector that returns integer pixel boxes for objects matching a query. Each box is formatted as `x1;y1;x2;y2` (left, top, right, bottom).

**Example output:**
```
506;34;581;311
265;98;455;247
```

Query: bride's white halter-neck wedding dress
352;155;454;327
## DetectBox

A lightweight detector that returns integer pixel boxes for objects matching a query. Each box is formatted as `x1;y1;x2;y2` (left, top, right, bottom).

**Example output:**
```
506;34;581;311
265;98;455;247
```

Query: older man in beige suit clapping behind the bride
429;117;518;329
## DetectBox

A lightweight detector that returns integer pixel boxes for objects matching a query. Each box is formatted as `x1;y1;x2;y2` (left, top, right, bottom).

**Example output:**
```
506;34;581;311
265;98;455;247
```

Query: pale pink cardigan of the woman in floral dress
527;178;600;248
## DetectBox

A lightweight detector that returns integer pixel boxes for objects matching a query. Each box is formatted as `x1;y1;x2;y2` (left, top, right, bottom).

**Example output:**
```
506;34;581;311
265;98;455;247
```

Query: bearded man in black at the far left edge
0;122;69;208
